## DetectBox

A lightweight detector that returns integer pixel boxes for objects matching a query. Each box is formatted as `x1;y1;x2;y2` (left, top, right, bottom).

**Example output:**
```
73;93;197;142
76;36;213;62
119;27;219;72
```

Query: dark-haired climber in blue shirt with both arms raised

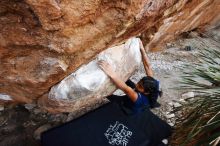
98;40;162;113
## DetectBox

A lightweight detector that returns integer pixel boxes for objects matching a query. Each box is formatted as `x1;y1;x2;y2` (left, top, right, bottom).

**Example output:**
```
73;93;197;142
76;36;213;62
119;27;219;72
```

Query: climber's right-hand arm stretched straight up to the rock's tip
139;40;153;77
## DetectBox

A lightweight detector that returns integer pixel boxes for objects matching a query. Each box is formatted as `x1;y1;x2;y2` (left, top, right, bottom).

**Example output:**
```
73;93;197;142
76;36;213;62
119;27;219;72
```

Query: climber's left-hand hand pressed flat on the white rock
98;60;116;78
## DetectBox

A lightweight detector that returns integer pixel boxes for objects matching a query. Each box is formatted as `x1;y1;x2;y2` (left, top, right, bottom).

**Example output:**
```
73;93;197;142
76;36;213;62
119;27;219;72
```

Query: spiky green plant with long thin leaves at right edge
171;49;220;146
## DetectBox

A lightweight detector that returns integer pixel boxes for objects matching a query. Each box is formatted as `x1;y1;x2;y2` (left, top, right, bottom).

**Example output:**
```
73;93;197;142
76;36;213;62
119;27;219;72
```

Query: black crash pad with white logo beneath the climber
41;102;171;146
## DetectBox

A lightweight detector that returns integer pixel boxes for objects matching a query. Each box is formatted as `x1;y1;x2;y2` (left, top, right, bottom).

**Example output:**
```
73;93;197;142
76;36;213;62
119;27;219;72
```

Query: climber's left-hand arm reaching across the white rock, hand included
98;61;138;102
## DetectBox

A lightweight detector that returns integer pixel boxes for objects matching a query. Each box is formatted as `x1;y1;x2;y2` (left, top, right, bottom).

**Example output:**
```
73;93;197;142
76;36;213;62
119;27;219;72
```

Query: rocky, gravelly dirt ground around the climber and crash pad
0;36;216;146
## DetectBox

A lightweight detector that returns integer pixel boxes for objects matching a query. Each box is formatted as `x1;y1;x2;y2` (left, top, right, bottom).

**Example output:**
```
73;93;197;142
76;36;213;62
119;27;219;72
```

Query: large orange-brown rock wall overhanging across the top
0;0;220;108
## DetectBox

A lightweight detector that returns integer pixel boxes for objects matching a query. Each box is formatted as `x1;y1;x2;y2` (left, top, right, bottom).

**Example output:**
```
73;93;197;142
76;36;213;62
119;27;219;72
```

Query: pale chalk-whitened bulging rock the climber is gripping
39;38;141;112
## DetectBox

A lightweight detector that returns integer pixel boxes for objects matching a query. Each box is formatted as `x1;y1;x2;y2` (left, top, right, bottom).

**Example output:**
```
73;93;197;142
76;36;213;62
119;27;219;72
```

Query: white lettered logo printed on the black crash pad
104;121;132;146
